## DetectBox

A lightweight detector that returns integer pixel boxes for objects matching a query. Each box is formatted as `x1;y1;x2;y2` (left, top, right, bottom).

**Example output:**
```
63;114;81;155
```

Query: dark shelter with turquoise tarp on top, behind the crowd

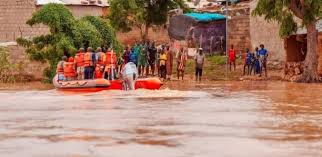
168;13;226;54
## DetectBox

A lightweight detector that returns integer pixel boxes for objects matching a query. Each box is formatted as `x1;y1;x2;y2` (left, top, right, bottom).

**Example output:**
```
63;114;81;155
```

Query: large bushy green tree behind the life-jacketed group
17;4;121;81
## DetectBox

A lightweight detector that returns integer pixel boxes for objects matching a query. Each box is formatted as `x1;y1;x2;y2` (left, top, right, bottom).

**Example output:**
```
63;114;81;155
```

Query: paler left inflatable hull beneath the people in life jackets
53;75;111;92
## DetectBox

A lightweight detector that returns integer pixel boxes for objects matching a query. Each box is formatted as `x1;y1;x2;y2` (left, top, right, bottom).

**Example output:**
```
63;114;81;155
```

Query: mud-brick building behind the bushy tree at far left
0;0;108;79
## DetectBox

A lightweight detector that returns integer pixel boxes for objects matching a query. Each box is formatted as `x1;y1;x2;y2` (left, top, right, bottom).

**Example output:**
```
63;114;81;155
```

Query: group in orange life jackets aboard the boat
56;47;117;81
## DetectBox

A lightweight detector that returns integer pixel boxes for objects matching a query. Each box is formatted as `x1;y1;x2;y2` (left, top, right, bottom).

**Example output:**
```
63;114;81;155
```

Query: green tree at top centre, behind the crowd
109;0;188;39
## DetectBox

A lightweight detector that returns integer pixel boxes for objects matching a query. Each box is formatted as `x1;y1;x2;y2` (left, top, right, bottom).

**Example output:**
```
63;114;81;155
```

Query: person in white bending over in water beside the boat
122;62;139;90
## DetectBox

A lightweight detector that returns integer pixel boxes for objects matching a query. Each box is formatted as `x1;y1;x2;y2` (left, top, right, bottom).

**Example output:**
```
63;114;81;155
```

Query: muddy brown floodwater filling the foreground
0;82;322;157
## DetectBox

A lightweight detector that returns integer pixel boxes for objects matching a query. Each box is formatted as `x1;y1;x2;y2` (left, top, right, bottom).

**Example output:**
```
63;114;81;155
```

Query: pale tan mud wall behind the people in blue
250;0;286;61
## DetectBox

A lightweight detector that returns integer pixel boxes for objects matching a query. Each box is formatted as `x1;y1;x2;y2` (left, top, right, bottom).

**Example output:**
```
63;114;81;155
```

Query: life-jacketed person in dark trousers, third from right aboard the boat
84;47;96;79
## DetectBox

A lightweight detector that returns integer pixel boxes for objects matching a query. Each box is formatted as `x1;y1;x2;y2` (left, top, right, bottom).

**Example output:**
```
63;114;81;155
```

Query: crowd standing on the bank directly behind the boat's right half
122;41;192;80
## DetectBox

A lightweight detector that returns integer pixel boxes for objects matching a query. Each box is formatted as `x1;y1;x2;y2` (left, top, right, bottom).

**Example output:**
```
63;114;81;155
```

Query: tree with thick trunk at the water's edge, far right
252;0;322;82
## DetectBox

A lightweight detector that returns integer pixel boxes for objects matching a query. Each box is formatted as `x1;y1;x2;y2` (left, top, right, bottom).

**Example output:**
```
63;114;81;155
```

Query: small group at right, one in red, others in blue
228;44;268;77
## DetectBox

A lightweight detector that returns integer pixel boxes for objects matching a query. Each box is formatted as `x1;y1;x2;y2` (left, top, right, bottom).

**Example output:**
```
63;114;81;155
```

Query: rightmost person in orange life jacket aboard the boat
104;49;117;80
